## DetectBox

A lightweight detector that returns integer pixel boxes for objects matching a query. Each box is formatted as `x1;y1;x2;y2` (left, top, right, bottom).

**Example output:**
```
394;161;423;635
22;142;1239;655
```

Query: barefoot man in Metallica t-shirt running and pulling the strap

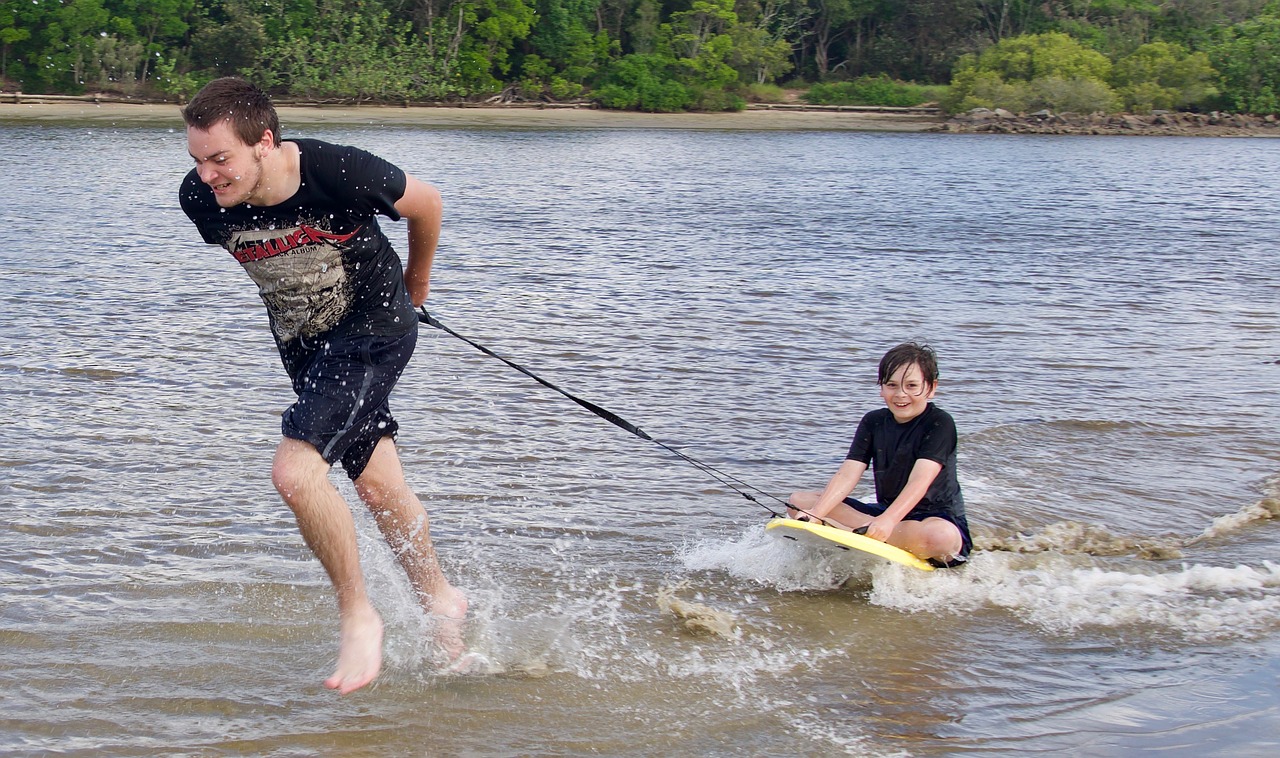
179;77;467;694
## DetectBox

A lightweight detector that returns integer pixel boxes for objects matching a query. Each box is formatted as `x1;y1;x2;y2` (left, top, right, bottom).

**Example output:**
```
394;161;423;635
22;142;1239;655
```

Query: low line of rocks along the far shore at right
932;108;1280;137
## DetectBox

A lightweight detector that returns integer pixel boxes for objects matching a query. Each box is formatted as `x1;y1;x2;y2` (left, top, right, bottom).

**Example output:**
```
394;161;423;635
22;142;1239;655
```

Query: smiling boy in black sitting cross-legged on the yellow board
790;342;973;567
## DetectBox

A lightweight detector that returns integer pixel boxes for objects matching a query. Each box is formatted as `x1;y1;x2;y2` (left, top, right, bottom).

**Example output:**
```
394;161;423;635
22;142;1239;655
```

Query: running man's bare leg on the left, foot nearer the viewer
271;437;383;695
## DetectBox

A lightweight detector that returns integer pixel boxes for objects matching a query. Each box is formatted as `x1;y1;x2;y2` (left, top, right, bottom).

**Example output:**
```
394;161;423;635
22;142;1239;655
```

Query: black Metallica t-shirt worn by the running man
178;140;417;344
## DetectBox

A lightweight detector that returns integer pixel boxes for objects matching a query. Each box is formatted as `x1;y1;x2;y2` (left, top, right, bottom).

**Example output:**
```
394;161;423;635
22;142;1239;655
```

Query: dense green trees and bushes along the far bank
0;0;1280;113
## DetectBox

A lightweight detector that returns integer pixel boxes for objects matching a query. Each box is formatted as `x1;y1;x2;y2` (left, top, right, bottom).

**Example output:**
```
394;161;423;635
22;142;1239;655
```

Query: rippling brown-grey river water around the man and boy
0;115;1280;757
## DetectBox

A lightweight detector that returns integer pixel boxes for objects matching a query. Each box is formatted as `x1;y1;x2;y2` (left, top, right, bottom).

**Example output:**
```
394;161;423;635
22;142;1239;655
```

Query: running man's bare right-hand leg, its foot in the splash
356;437;467;661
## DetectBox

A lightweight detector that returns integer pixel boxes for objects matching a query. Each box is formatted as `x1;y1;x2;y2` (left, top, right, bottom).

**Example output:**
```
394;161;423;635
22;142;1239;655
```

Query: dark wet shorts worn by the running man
279;323;417;480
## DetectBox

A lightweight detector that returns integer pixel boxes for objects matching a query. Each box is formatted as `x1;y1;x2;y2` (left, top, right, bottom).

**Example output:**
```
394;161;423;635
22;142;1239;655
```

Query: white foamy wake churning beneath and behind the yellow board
682;526;1280;641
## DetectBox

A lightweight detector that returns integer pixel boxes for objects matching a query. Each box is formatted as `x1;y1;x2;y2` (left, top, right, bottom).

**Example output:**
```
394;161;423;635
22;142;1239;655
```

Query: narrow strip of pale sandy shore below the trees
0;102;943;132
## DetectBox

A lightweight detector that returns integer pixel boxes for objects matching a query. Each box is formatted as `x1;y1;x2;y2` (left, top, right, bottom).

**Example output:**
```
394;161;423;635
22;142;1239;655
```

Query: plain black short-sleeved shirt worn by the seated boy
845;403;964;519
